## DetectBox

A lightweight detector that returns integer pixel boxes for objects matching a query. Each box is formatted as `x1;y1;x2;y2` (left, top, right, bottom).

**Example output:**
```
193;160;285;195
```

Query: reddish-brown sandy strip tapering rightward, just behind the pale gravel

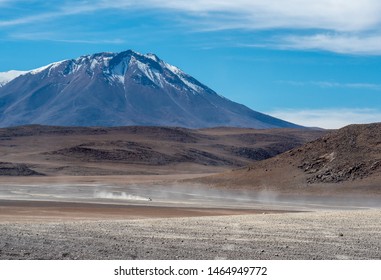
0;200;285;223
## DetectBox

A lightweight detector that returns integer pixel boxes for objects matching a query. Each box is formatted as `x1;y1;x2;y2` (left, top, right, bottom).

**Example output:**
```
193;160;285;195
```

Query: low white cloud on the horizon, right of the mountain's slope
268;108;381;129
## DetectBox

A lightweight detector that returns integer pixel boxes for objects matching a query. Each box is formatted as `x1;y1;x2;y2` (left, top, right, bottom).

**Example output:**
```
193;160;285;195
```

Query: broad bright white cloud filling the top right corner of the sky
142;0;381;31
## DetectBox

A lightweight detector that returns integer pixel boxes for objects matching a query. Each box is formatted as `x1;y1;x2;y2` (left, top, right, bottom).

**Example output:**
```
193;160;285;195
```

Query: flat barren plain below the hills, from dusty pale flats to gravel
0;176;381;259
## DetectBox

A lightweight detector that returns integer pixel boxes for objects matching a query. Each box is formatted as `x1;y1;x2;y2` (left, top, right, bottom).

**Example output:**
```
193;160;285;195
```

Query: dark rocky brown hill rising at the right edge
202;123;381;195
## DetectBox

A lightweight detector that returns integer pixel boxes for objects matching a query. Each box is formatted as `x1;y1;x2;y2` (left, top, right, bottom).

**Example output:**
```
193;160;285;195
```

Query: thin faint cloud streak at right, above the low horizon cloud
277;81;381;91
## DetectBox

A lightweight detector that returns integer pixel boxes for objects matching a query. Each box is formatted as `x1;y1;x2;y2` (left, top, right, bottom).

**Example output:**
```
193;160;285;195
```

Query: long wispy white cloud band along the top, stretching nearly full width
14;0;381;32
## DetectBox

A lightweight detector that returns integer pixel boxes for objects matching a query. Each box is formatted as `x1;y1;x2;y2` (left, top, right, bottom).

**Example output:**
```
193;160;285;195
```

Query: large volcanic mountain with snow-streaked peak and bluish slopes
0;50;297;128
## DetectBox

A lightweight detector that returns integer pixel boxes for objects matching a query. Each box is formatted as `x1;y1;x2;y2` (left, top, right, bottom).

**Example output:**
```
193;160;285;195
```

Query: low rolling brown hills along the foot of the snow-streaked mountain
0;125;326;176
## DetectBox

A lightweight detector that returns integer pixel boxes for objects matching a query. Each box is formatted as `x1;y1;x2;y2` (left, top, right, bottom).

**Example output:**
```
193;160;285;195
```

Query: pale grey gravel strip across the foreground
0;209;381;259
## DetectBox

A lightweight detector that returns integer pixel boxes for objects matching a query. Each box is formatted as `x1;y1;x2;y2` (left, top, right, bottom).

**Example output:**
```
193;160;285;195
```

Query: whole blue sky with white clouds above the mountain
0;0;381;128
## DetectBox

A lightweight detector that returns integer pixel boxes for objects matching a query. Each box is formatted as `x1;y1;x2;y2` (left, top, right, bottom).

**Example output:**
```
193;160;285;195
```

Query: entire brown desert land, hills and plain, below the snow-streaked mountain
0;125;381;259
